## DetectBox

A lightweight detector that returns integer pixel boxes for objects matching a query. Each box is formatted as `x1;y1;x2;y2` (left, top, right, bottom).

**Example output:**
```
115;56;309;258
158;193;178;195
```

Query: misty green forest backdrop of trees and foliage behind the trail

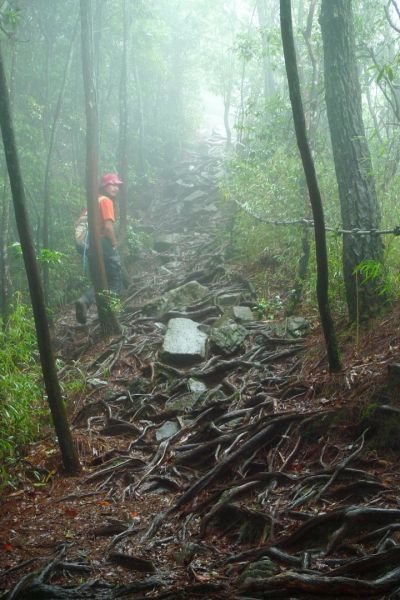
0;0;400;482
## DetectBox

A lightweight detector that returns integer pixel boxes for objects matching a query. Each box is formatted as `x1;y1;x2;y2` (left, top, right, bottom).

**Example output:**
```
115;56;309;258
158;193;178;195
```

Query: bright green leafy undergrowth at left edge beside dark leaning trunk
0;299;46;491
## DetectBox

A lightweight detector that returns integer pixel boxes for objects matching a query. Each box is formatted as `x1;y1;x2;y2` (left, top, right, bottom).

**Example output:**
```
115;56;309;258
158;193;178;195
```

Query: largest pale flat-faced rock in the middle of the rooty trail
161;318;207;364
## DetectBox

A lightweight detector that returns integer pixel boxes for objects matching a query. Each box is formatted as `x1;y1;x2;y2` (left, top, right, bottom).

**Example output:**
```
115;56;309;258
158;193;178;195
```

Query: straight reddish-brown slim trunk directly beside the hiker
80;0;120;333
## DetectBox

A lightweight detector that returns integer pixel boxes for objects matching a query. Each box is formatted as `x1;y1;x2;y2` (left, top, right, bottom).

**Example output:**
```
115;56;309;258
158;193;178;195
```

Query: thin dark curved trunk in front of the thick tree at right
280;0;341;372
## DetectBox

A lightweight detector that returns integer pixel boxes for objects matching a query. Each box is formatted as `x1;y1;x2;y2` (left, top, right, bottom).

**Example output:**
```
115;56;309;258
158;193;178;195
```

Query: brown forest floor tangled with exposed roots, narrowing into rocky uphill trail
0;137;400;600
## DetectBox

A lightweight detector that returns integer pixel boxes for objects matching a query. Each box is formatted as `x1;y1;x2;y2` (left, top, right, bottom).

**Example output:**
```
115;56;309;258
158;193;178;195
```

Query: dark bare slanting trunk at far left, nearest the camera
0;41;80;474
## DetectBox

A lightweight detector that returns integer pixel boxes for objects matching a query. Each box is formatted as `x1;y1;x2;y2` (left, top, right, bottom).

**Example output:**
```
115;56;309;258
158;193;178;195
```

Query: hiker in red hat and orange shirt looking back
75;173;122;325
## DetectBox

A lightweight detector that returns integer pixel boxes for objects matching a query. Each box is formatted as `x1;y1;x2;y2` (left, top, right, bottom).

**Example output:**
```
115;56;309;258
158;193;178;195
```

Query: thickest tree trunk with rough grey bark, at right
320;0;383;321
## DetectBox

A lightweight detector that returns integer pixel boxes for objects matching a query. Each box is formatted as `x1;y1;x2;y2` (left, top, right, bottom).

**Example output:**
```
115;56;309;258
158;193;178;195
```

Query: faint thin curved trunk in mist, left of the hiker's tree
42;21;79;306
